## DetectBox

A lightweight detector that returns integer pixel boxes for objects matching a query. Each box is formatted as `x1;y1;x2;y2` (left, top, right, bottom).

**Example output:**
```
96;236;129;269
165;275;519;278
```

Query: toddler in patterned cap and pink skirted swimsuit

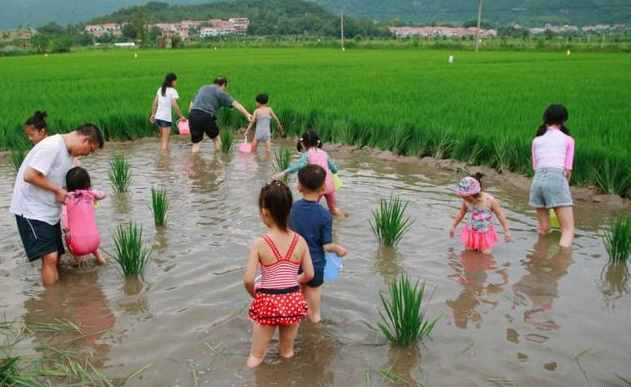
449;173;512;254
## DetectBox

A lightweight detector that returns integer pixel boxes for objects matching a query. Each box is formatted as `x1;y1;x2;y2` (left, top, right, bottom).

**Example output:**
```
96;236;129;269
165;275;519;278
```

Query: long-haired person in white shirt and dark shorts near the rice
149;73;186;151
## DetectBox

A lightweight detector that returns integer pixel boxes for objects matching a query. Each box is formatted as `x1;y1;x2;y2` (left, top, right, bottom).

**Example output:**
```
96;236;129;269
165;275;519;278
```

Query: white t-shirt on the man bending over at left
9;134;72;226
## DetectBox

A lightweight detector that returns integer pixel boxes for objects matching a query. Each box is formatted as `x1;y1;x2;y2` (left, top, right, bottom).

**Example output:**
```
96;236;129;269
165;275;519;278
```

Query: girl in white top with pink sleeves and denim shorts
529;105;574;247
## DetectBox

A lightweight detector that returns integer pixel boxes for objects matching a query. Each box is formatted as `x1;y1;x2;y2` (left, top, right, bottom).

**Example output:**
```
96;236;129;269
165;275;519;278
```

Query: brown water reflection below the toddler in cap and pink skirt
447;251;508;329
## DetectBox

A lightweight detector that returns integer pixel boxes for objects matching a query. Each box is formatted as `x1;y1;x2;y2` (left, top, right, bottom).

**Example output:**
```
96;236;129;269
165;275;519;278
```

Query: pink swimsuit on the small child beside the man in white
62;190;105;256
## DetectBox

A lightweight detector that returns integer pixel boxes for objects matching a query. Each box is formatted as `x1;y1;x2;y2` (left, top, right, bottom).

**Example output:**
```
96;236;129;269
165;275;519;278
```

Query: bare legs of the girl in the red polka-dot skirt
247;322;299;368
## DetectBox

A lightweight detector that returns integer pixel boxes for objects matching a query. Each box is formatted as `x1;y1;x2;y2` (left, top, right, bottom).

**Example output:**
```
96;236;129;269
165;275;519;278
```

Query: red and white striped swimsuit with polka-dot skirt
249;233;307;326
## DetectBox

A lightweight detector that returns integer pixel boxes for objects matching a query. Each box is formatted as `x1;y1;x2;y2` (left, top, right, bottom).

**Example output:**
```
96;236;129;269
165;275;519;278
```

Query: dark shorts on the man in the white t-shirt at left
15;215;66;262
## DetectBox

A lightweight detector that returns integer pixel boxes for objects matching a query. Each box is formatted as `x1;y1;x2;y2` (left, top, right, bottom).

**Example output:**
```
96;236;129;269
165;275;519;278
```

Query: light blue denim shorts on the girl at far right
529;168;574;208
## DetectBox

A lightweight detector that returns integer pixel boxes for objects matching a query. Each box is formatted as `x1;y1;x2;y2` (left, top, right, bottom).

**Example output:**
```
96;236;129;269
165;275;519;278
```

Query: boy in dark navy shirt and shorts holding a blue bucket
289;165;346;323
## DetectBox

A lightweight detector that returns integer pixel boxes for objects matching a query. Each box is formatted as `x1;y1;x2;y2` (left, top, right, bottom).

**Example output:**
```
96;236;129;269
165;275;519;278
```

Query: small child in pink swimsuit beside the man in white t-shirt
62;167;105;265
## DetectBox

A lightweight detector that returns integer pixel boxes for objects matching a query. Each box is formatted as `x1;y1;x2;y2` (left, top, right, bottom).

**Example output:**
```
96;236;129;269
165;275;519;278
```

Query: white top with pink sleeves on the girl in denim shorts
532;127;574;170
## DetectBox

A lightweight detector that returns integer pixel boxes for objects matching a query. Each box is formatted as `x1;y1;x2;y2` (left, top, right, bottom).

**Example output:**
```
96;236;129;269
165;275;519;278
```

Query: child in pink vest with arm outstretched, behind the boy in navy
274;130;344;216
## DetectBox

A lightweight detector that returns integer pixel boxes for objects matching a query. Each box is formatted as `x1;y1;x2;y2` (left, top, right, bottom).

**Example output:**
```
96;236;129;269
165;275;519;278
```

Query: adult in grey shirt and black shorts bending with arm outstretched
189;77;252;153
